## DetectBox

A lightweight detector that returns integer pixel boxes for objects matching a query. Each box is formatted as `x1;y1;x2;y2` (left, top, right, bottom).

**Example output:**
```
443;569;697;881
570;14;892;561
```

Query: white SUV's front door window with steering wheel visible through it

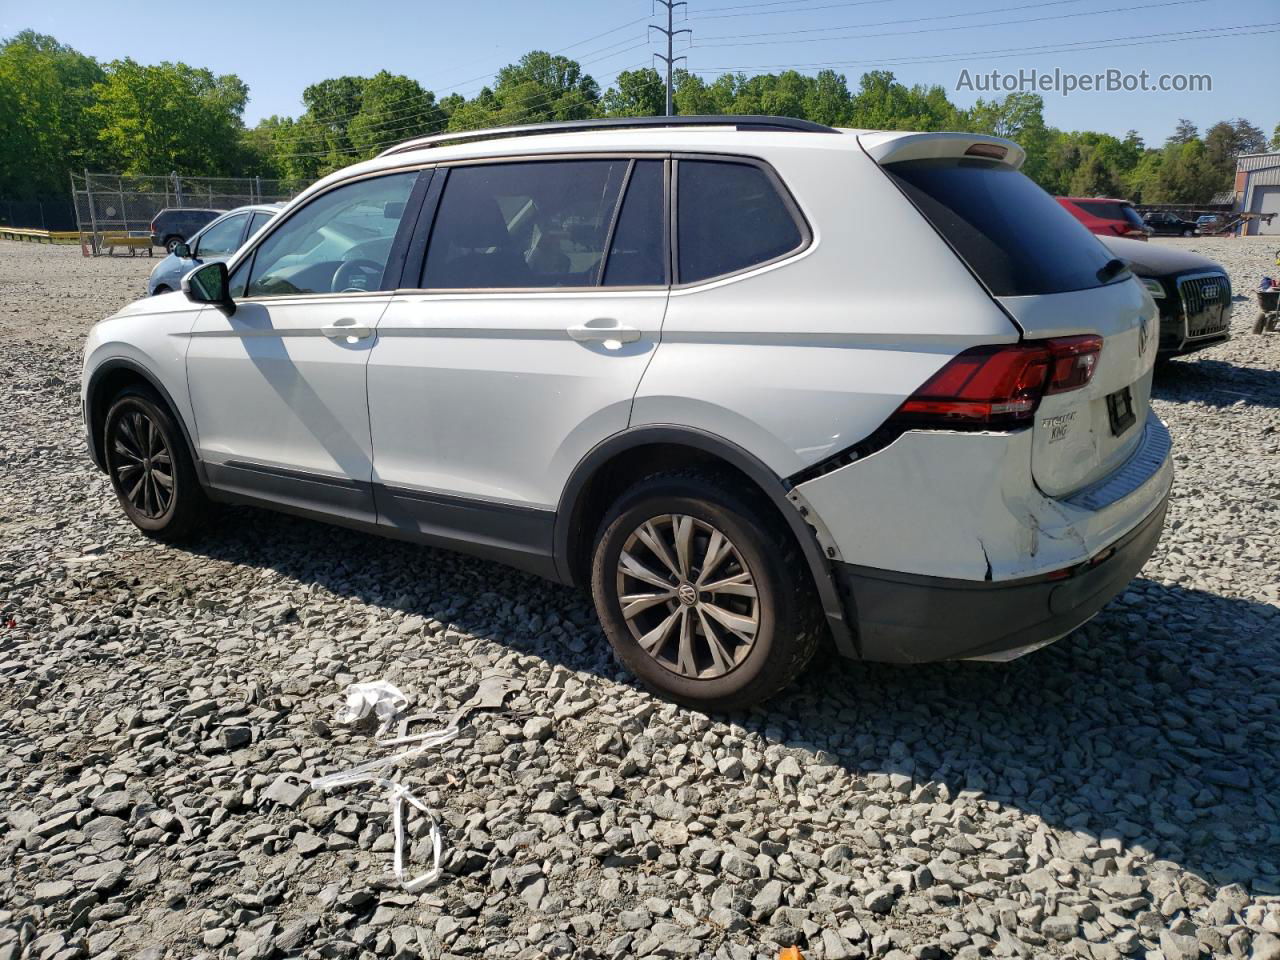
238;170;417;297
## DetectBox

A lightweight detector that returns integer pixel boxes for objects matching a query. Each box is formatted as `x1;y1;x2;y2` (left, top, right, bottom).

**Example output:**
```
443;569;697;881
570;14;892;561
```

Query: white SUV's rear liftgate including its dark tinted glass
884;148;1156;497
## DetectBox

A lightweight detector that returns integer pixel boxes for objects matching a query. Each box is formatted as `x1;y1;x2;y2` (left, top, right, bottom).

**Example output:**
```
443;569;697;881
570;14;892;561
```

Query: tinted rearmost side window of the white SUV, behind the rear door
676;160;804;283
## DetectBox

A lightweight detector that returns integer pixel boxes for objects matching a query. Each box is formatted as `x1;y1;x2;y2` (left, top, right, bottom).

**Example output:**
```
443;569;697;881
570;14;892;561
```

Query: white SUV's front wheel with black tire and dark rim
102;387;209;543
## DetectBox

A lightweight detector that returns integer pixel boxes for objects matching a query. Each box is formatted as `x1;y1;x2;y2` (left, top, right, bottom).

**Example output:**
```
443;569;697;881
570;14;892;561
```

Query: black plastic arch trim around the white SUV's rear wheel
553;424;859;657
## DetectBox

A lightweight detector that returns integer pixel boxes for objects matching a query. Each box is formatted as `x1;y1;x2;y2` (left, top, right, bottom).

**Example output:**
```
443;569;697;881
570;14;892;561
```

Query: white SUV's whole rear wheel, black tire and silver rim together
591;470;826;710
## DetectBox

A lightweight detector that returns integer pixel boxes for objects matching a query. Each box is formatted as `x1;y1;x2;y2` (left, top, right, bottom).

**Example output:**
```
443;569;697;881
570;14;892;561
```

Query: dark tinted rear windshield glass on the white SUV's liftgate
884;159;1111;297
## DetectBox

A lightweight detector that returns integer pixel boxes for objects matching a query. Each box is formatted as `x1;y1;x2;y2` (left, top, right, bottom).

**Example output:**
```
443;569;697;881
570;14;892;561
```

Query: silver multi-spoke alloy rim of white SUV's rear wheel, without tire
617;513;760;680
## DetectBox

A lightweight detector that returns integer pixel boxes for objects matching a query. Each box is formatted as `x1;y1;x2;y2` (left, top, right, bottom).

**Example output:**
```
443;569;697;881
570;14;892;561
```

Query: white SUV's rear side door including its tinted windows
369;156;668;553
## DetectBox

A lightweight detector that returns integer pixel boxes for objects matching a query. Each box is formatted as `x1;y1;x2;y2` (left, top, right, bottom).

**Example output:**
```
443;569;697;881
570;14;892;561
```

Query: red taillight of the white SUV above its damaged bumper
893;335;1102;428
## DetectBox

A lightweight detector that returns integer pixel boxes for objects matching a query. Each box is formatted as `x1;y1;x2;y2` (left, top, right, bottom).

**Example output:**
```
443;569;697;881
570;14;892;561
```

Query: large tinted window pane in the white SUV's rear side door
421;159;630;289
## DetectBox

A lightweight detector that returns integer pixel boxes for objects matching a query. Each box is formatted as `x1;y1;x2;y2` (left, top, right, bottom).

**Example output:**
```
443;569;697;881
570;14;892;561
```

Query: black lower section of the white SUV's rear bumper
835;492;1169;663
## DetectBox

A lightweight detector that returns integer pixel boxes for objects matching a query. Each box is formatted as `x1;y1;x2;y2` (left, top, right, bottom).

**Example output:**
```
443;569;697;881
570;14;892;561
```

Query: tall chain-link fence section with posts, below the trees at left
72;170;307;256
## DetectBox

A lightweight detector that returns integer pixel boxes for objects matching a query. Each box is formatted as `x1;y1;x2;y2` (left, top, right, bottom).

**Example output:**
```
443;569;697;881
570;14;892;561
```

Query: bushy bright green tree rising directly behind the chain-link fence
88;58;248;175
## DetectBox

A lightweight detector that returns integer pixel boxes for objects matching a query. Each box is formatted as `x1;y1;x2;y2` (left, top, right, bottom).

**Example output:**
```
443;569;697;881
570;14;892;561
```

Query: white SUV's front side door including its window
187;172;417;522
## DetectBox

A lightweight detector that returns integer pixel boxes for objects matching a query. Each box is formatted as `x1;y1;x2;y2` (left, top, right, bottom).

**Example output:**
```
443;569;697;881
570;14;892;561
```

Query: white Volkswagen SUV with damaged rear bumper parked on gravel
83;116;1171;708
